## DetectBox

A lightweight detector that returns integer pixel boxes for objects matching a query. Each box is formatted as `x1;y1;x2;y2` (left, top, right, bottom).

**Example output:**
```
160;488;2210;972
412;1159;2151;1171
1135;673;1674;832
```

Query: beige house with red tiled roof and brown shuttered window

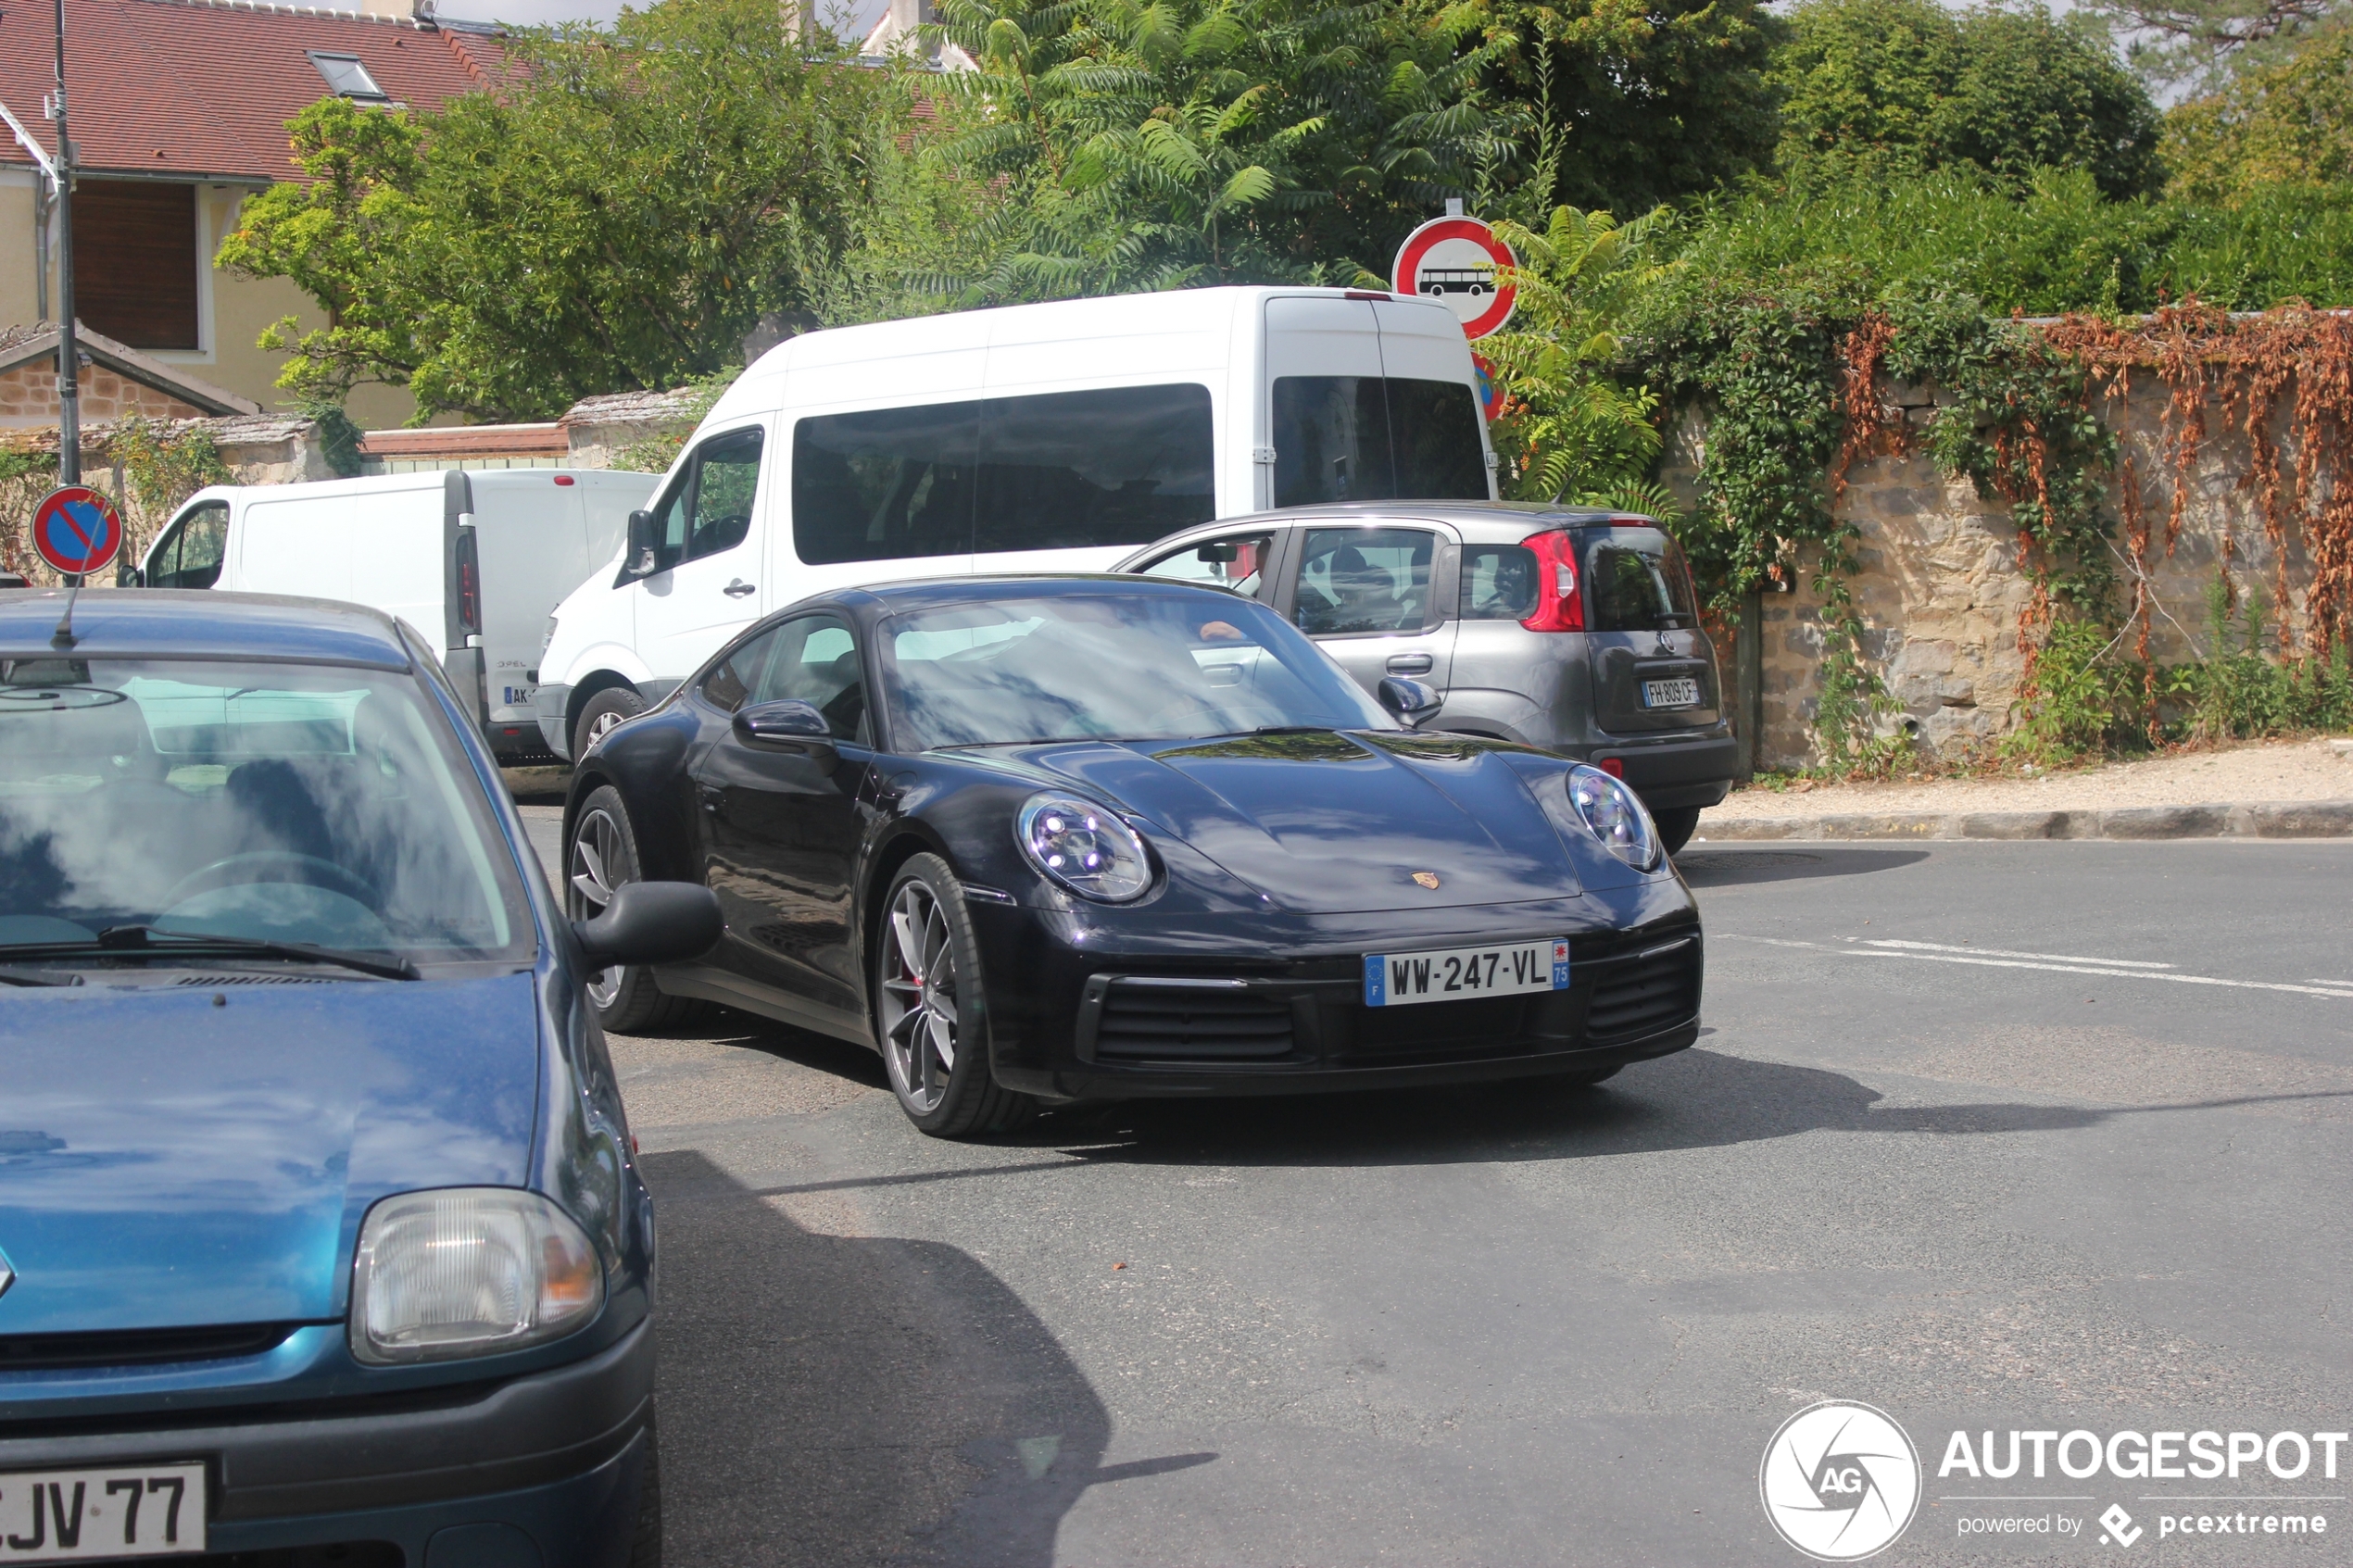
0;0;501;428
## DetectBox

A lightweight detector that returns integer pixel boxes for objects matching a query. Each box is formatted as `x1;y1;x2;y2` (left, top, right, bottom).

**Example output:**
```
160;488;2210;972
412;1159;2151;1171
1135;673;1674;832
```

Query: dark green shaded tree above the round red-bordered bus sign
1459;0;1786;211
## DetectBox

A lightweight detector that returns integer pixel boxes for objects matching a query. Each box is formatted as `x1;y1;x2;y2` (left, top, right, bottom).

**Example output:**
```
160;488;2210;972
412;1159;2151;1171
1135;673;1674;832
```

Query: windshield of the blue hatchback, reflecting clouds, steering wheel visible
0;659;532;964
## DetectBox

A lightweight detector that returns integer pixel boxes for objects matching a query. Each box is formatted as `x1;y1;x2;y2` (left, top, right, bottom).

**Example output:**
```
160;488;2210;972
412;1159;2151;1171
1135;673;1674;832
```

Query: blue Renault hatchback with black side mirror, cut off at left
0;590;720;1568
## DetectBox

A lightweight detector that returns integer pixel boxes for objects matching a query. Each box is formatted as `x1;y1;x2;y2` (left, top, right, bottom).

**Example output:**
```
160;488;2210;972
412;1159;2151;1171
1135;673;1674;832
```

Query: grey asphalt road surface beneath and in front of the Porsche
510;811;2353;1568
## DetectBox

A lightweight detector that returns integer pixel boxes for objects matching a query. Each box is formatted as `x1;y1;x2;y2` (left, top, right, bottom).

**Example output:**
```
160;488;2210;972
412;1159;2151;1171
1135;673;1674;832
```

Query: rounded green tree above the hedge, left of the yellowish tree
1772;0;2162;197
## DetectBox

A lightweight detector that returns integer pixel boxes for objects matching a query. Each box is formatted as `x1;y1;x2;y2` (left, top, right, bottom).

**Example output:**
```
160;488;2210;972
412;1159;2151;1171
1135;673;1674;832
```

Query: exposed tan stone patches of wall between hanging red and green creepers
1666;376;2313;766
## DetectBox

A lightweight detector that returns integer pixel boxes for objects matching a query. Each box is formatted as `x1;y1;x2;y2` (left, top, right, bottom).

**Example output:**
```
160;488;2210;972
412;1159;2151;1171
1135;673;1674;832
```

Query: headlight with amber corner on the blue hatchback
350;1187;605;1366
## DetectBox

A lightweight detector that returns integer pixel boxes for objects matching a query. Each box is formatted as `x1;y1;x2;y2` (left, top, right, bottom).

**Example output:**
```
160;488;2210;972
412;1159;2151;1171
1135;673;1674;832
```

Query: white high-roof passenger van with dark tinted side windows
539;289;1494;757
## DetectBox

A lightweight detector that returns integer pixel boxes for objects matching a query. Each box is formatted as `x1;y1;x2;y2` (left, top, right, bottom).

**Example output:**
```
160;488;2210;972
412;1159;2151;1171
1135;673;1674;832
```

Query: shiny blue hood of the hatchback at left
0;973;539;1336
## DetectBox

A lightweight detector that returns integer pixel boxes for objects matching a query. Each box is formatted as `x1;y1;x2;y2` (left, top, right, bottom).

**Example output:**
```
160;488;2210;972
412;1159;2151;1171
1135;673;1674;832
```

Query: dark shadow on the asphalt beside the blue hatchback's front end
642;1152;1216;1568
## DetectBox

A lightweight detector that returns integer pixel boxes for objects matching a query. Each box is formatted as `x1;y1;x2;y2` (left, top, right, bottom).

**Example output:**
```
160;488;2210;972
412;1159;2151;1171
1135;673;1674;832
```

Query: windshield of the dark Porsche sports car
883;593;1395;750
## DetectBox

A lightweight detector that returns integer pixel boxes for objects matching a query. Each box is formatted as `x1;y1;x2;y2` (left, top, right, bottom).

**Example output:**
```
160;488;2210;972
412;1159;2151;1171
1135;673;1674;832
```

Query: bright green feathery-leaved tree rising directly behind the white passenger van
908;0;1508;303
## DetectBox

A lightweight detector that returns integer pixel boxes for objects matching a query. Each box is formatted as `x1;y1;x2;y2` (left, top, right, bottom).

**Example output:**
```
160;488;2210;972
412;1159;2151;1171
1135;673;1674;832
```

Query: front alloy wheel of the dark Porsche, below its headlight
875;856;1036;1138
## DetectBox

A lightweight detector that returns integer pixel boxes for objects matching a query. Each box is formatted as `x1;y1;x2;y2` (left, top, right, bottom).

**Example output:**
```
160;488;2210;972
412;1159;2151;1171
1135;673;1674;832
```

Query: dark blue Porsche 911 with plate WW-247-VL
565;576;1701;1135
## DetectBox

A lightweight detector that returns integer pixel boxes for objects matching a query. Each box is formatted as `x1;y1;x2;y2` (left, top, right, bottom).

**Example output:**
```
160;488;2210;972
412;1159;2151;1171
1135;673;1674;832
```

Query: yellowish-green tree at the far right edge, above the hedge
2165;26;2353;205
